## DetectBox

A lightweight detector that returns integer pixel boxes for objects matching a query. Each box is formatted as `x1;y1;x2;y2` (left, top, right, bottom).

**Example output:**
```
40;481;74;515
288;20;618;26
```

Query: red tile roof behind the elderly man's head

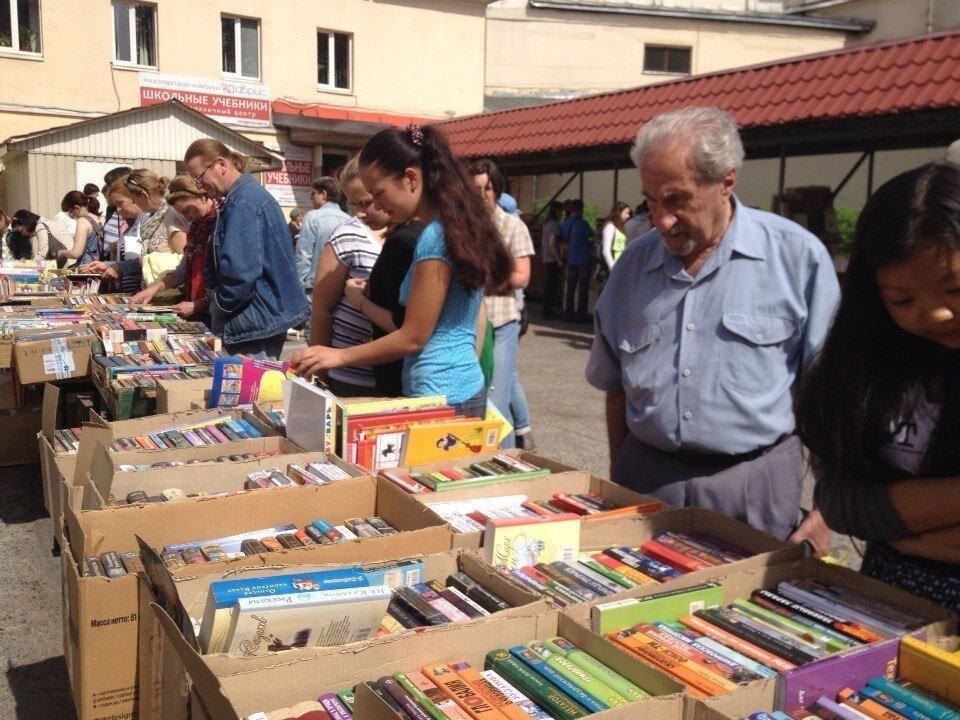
439;28;960;158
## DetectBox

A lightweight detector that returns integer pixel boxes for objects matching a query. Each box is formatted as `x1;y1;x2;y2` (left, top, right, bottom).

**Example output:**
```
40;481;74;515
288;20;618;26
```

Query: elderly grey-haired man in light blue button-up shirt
587;107;839;553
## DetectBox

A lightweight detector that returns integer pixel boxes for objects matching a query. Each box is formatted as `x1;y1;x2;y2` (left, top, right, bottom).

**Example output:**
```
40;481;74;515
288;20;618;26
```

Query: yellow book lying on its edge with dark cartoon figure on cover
400;420;501;467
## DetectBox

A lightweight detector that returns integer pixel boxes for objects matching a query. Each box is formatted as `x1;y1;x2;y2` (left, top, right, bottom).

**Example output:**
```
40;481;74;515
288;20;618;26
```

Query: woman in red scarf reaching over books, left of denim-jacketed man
130;175;218;325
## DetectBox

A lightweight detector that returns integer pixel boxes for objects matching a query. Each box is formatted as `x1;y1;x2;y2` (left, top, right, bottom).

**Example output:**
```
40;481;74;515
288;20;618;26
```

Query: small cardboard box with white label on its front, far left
13;325;100;385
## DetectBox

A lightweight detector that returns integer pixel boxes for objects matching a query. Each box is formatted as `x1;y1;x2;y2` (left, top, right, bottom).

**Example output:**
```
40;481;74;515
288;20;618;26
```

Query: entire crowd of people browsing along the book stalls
0;108;960;610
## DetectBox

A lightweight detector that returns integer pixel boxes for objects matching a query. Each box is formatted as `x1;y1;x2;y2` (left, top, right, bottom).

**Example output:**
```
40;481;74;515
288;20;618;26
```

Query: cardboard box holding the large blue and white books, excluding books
140;550;550;720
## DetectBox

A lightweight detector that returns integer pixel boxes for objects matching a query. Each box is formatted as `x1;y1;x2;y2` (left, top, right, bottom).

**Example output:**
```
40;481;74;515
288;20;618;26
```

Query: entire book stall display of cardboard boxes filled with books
0;276;960;720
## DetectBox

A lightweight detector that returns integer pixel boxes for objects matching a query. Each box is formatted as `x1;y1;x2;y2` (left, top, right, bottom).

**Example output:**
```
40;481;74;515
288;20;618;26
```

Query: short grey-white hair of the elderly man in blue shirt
630;107;744;184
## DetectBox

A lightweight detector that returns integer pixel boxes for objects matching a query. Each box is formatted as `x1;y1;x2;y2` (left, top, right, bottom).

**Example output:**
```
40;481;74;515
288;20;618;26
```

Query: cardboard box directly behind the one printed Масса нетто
81;436;364;512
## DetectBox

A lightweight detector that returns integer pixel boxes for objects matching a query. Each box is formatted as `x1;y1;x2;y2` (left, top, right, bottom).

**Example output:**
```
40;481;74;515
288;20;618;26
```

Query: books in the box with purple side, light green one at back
592;580;926;698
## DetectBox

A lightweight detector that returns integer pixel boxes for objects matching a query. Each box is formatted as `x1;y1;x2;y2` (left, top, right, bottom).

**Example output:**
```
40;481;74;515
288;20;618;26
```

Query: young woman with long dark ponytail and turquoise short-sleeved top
292;125;513;417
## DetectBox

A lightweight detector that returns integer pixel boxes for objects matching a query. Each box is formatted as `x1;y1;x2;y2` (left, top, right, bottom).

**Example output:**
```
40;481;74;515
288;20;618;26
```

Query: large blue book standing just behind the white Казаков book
199;567;371;653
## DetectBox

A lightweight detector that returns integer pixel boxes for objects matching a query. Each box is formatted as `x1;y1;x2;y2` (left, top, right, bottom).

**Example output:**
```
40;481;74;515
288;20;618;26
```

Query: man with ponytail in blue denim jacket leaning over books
184;140;310;358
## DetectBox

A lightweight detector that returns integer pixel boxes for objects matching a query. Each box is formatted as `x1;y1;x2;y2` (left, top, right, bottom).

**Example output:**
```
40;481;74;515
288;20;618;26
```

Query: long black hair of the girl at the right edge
796;162;960;480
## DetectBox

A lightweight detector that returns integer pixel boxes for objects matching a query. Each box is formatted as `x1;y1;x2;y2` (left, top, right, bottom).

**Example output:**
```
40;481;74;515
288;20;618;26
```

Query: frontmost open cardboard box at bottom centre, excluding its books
152;605;684;720
